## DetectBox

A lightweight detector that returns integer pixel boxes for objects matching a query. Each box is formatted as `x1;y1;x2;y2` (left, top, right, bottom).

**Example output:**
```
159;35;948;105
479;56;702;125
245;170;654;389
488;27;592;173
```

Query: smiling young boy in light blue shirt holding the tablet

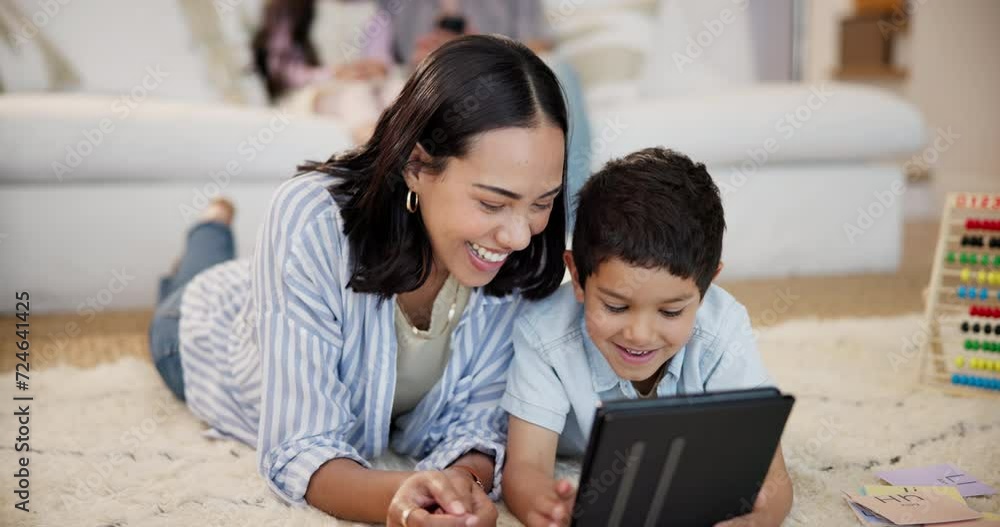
501;148;792;527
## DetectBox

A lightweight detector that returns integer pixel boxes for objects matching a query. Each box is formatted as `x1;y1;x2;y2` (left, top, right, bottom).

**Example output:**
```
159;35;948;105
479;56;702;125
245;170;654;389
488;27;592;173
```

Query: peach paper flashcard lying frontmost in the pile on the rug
848;492;983;525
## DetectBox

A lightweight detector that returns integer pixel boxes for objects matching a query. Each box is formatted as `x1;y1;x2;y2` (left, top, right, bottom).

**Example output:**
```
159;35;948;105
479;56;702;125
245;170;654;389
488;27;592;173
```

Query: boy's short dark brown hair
573;148;726;297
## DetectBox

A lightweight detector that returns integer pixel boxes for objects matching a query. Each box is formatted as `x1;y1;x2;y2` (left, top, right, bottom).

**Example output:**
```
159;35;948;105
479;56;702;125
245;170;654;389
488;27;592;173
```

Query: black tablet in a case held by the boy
573;388;795;527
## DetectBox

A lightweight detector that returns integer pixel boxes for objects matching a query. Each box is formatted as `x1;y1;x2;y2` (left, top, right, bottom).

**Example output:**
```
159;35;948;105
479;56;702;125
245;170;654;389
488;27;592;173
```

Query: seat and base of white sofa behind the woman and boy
0;0;926;312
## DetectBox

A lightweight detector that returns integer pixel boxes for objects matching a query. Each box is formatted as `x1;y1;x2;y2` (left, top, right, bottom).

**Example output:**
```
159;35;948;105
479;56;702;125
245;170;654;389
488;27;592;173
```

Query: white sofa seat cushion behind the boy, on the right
591;83;927;168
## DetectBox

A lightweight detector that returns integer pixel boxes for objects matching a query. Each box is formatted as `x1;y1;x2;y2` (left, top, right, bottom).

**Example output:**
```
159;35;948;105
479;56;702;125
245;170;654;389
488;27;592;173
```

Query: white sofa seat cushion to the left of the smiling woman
0;94;351;184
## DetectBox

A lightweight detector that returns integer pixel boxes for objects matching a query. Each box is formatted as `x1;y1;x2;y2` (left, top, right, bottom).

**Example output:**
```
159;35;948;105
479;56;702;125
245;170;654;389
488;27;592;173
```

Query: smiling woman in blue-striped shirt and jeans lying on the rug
151;36;567;527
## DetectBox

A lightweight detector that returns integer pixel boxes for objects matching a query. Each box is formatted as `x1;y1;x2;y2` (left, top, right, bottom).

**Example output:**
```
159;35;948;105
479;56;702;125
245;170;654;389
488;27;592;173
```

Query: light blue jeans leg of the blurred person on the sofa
550;59;593;236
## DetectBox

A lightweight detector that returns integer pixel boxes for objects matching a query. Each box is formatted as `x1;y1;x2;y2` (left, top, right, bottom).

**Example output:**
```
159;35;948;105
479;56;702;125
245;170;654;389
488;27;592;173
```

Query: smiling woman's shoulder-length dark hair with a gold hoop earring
299;35;568;299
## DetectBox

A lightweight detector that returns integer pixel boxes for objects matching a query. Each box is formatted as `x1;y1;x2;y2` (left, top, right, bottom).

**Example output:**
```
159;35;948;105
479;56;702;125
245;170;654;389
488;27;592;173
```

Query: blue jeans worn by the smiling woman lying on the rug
149;223;236;401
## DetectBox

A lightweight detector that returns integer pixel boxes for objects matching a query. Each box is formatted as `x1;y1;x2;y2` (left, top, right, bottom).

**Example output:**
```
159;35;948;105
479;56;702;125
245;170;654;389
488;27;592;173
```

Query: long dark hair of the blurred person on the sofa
251;0;319;102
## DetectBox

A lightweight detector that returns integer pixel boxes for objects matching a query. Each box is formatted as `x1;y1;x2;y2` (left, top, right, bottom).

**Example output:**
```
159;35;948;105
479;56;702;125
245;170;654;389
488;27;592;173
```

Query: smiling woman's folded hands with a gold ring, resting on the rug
386;470;488;527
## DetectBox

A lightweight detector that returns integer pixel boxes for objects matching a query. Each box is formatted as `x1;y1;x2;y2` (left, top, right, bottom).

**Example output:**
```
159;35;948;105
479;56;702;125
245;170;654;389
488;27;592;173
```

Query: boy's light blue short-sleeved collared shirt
500;283;771;455
